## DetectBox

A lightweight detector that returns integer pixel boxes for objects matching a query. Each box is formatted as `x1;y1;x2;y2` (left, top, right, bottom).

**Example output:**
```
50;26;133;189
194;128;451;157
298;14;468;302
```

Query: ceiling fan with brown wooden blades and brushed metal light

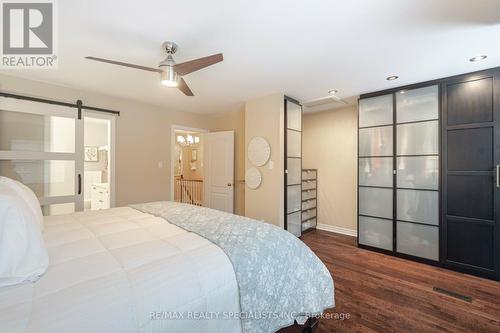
85;42;224;96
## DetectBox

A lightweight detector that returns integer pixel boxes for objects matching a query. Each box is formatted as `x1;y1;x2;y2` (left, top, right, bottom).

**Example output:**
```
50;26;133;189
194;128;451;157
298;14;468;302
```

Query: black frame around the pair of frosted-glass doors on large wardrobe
356;80;443;266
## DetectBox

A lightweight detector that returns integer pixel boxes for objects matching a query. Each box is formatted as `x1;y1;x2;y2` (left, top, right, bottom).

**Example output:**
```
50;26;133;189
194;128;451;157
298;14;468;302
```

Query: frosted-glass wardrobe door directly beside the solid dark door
396;85;439;261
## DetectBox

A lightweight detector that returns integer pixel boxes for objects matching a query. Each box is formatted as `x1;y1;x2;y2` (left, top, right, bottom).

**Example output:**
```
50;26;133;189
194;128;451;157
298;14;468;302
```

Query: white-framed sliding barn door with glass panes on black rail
0;97;83;215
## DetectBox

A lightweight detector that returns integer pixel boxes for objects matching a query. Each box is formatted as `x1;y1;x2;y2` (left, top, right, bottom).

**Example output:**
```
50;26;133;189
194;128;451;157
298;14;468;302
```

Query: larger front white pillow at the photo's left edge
0;182;49;287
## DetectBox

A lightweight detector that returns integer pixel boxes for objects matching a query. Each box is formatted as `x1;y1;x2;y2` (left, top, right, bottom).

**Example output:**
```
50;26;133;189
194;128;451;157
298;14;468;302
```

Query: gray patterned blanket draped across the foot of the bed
131;202;335;333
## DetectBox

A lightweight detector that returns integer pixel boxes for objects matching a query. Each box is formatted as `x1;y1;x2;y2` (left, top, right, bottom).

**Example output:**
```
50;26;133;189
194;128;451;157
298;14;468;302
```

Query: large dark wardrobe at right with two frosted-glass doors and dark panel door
358;68;500;280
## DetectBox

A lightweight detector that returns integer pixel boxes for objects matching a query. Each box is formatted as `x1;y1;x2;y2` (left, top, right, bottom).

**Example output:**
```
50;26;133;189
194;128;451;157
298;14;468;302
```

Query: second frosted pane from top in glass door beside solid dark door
397;120;439;155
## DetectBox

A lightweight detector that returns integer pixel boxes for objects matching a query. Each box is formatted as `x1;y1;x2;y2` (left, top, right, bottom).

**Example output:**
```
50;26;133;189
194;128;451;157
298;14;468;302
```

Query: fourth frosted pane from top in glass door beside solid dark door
397;189;439;225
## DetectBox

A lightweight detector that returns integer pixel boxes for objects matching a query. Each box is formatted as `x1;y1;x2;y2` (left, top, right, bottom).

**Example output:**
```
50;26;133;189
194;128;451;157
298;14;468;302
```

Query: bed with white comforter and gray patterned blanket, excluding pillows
0;202;334;333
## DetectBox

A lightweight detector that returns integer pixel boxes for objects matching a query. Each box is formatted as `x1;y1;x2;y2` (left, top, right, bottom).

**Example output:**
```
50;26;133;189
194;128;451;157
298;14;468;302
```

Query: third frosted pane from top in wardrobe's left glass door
359;157;393;187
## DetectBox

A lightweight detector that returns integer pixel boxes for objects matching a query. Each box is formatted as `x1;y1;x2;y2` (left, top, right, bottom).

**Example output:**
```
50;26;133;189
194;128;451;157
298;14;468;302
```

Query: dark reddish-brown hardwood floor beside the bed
287;230;500;333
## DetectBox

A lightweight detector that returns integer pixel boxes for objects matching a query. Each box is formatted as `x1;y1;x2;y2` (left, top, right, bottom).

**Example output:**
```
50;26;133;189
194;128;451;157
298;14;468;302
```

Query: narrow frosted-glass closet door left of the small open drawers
285;98;302;237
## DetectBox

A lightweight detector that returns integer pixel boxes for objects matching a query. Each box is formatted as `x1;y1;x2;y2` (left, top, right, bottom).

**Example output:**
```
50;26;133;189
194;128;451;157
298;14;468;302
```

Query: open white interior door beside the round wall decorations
203;131;234;213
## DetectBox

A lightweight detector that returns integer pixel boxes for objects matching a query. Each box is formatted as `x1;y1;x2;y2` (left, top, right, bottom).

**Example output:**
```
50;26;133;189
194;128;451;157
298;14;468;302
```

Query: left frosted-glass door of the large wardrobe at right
358;94;394;251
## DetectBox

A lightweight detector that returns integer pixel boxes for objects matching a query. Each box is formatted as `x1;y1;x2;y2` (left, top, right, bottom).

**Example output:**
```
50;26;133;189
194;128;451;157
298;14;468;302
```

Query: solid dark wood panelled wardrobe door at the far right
441;71;500;279
